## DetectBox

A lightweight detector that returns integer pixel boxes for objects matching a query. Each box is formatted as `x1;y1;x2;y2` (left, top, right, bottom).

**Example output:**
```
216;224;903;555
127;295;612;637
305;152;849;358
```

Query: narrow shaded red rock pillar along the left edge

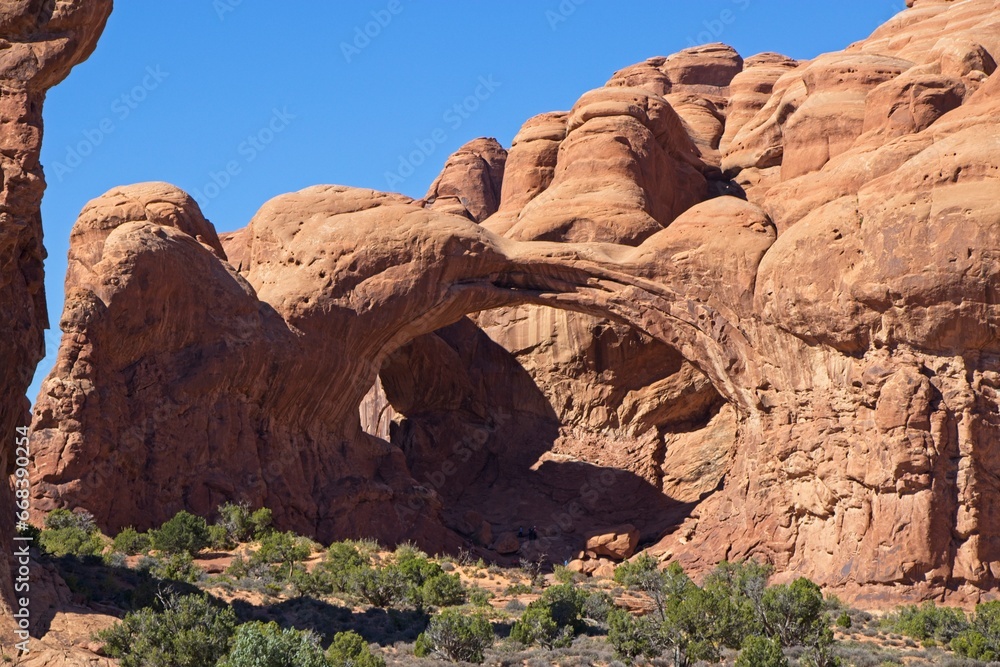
0;0;111;643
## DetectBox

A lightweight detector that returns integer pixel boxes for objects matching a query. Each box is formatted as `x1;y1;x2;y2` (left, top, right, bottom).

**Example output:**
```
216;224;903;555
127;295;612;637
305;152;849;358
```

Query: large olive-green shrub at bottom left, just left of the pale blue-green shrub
98;595;236;667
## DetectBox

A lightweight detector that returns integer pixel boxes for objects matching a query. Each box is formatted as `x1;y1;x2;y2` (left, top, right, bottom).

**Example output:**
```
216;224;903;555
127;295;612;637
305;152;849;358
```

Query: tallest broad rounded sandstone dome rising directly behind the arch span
501;87;706;244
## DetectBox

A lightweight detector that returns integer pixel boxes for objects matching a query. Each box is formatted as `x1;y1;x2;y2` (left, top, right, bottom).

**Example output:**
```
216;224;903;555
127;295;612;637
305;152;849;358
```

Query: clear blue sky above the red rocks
29;0;903;400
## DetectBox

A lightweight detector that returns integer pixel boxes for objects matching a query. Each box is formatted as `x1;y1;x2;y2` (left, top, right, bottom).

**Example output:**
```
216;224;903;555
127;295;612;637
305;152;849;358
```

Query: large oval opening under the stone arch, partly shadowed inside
361;305;736;562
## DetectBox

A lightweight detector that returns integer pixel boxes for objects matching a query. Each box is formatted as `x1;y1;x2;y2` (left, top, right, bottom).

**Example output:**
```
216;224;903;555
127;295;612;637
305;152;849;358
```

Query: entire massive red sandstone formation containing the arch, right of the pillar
27;0;1000;599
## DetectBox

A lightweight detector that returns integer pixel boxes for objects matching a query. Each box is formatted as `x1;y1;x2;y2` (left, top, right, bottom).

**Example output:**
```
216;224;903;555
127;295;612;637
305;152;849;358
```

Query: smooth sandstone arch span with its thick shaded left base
34;184;773;545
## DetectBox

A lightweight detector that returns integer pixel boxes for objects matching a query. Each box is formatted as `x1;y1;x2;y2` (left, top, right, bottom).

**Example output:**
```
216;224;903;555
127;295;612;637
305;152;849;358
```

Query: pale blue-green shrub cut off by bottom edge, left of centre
218;621;329;667
